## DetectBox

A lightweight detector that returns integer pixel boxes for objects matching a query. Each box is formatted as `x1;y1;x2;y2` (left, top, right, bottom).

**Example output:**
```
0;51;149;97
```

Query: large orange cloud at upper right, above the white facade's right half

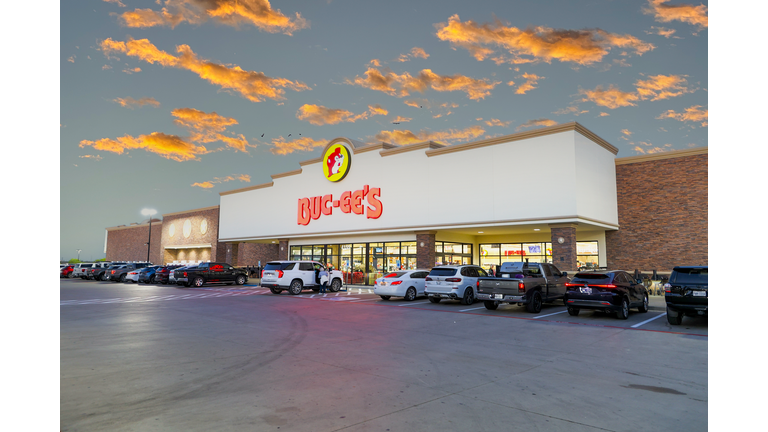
435;15;655;65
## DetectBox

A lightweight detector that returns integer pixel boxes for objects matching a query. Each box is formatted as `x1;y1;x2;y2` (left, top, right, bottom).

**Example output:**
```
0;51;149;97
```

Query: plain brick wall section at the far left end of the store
106;221;163;263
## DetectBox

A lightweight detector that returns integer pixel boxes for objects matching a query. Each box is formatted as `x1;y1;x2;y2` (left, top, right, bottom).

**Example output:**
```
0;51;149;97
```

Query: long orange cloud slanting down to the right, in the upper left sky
101;39;311;102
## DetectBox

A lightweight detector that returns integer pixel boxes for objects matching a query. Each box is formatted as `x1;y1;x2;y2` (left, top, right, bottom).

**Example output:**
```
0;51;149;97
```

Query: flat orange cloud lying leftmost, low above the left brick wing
80;132;209;162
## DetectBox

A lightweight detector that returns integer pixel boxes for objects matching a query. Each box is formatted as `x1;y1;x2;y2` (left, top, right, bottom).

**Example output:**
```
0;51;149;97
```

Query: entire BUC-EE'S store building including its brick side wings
106;123;708;284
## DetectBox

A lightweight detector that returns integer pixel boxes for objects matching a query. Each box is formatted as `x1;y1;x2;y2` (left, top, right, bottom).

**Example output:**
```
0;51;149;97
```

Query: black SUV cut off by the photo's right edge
664;266;709;325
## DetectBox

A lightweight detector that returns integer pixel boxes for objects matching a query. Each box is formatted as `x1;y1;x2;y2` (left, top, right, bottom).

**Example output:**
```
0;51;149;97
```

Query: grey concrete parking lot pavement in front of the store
60;279;708;431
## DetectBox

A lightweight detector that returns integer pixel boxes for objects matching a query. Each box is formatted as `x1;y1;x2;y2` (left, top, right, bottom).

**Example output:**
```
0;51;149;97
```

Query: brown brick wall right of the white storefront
605;154;709;271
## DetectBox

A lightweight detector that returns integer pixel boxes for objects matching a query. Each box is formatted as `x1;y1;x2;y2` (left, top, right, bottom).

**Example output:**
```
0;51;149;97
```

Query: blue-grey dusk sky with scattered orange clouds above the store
59;0;708;260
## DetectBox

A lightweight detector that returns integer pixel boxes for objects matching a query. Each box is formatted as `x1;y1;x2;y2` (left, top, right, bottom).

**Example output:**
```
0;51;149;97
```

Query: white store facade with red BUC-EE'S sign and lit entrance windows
219;123;618;284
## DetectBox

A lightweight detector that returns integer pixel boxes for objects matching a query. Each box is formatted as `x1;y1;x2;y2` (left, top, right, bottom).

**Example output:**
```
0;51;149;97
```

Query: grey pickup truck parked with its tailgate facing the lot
477;261;570;313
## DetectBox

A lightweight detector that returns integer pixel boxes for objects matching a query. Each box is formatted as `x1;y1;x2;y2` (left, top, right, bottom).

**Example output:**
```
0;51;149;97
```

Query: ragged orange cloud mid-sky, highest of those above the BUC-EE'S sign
345;68;500;100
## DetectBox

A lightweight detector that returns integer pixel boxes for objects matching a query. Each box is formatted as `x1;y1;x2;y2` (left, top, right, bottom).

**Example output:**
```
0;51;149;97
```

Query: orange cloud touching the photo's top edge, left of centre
120;0;309;35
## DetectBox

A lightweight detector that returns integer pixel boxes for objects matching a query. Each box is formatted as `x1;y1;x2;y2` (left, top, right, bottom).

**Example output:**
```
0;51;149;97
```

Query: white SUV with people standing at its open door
261;261;342;295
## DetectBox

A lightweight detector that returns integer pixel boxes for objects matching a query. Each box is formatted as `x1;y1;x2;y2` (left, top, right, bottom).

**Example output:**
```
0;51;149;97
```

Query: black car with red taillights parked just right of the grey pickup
565;270;648;319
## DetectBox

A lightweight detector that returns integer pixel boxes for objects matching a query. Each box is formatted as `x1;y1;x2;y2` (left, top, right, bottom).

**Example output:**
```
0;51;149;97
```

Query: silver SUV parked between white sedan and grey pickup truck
424;265;488;305
